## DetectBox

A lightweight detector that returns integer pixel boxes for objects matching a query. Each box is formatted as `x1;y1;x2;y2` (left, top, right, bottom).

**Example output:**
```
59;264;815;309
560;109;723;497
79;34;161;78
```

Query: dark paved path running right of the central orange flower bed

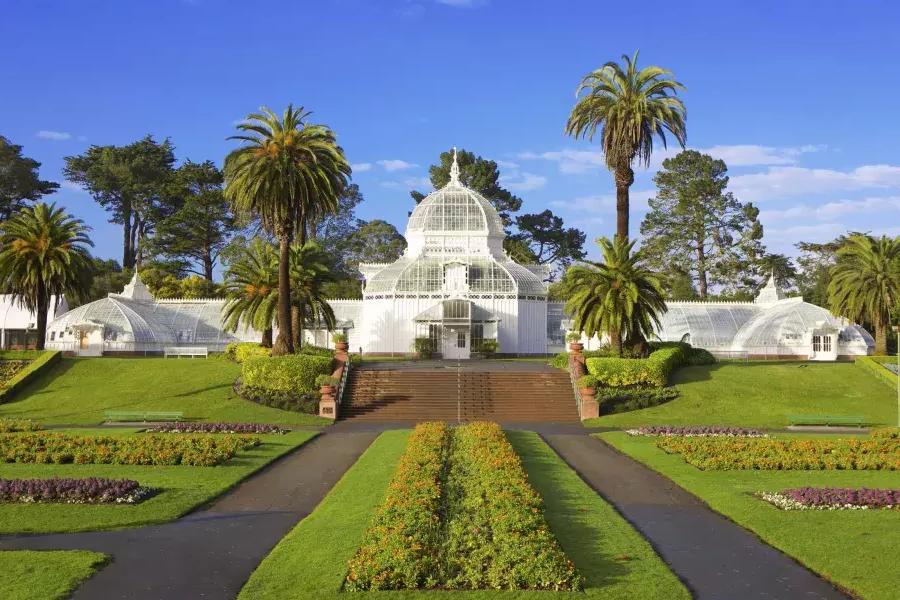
542;432;848;600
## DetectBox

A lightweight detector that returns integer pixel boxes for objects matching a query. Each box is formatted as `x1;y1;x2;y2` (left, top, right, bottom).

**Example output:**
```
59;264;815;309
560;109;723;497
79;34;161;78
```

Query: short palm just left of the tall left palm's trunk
222;238;278;348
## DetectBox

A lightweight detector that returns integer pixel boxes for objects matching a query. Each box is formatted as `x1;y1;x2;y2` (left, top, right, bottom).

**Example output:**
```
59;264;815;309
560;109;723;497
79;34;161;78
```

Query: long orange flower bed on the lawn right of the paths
656;436;900;470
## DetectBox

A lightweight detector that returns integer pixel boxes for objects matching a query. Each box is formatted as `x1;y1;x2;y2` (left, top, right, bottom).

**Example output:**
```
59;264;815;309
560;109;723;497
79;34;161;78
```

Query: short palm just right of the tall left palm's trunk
291;242;337;351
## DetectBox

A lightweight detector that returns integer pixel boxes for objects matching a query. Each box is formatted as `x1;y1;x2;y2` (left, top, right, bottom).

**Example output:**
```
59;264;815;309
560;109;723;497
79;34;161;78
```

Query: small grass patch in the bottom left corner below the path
0;550;107;600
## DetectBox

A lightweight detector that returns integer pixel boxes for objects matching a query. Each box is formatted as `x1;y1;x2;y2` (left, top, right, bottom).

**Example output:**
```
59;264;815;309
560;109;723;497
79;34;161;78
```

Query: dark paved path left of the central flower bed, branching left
0;431;377;600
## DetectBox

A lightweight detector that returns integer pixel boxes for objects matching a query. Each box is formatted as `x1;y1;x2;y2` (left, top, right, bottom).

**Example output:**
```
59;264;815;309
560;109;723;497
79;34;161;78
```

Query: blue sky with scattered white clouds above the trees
0;0;900;258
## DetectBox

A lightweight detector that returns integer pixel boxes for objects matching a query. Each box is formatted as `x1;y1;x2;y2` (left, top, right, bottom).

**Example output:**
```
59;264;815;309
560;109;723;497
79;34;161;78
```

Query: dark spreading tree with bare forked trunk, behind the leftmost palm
64;135;180;269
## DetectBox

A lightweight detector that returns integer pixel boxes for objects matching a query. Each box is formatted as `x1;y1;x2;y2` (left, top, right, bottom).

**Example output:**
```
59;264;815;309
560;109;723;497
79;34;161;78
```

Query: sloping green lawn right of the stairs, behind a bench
585;362;897;429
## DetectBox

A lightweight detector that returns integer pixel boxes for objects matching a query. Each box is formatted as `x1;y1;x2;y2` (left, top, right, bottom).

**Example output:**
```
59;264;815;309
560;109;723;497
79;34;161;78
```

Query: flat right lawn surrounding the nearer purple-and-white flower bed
598;432;900;600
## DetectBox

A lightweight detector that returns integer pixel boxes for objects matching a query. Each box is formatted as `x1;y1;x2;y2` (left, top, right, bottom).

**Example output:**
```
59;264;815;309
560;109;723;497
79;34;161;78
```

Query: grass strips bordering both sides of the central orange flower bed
240;431;690;600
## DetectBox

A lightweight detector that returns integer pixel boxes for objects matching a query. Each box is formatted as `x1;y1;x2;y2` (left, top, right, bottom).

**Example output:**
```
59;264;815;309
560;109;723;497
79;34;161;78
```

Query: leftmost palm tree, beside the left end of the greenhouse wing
0;202;94;350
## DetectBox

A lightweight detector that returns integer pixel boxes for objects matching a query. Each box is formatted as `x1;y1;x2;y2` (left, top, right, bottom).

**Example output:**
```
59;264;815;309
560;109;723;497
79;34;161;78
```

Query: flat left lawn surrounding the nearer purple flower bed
0;430;316;534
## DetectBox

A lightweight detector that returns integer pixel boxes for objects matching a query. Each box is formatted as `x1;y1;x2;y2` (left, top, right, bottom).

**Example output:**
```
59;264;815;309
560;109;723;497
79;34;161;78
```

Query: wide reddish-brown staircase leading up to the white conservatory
339;369;579;422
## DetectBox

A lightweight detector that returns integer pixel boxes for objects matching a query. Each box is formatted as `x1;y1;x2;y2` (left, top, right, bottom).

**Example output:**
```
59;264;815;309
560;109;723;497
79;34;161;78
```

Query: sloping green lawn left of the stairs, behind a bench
0;357;330;425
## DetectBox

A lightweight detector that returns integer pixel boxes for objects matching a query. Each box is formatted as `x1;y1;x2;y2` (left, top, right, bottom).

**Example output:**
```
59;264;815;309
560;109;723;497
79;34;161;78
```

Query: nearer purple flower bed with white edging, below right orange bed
758;487;900;510
